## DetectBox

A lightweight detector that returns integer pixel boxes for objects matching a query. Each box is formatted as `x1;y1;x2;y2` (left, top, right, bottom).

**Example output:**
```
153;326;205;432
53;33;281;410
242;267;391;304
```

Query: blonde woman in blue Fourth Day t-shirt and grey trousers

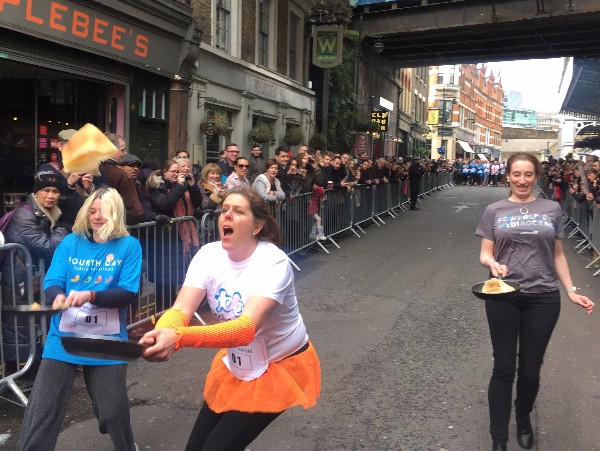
21;188;142;451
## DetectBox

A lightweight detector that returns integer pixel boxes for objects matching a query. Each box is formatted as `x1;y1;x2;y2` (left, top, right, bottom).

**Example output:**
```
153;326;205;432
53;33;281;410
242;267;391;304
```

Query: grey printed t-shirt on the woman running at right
475;198;564;293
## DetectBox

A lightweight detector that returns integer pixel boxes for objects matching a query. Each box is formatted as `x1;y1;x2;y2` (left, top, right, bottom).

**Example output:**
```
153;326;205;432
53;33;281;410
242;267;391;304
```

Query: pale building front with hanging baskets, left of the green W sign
186;0;315;164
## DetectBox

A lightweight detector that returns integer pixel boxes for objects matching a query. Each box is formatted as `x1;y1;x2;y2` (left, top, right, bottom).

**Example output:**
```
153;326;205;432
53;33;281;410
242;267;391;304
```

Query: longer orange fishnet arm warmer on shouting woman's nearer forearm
175;315;256;349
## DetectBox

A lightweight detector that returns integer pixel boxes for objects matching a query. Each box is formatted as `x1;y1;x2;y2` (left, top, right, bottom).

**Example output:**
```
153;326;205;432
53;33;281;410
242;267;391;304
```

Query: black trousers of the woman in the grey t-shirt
485;290;560;441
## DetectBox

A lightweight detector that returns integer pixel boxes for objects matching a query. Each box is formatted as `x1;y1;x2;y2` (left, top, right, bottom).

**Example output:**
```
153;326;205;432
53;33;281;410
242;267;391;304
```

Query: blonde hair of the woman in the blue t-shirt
73;188;129;241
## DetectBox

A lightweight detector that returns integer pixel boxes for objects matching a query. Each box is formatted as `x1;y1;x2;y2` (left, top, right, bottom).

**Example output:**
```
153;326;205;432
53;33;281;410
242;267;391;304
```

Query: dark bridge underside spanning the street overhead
354;0;600;67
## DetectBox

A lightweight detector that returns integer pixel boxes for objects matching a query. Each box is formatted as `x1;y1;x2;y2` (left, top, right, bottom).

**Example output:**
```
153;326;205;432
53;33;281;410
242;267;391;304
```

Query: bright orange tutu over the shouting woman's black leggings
204;341;321;413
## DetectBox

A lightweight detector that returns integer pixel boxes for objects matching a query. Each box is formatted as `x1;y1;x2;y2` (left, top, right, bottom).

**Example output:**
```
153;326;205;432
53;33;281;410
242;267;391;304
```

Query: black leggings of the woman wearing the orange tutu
185;403;281;451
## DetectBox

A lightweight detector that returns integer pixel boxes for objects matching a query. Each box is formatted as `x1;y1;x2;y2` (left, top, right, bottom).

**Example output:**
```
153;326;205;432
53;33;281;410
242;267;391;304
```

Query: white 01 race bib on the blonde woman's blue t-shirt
58;302;121;335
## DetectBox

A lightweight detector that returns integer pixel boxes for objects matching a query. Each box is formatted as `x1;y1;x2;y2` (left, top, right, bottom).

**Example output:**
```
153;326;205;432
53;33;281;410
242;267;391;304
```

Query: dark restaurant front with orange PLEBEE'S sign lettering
0;0;201;192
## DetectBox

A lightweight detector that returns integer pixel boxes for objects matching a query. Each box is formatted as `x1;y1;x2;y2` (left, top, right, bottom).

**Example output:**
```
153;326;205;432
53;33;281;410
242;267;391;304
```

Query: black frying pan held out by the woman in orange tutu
60;334;146;361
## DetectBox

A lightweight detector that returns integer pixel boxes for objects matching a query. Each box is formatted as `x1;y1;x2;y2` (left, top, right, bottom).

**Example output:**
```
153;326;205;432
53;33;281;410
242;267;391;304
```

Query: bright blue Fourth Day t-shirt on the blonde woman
42;233;142;365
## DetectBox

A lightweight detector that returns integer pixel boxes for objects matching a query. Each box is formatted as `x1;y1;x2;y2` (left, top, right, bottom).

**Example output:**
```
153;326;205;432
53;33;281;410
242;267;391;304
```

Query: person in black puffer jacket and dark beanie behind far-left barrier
1;171;69;363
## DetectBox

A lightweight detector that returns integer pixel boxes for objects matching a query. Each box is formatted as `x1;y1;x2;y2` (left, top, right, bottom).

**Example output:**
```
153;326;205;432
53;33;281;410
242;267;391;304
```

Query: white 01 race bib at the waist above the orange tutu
223;339;269;381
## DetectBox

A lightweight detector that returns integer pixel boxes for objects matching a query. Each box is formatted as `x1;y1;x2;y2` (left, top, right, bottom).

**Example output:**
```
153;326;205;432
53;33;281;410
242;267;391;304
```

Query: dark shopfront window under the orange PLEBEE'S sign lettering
0;61;106;193
